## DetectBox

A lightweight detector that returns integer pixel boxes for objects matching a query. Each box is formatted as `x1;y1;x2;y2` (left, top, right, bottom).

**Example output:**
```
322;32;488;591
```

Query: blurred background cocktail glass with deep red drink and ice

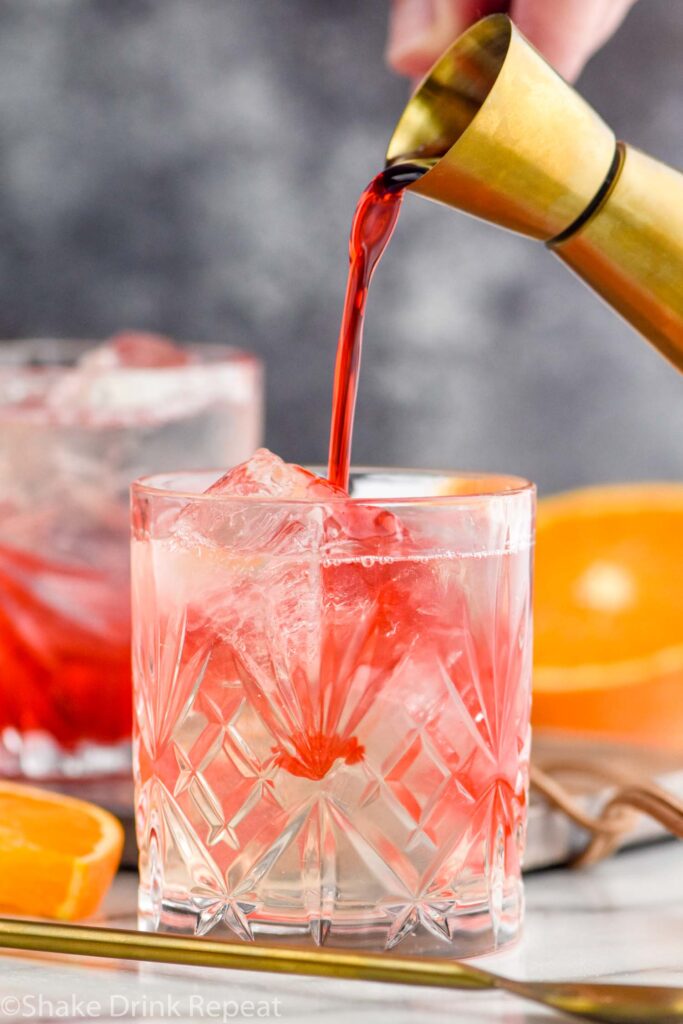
0;334;262;776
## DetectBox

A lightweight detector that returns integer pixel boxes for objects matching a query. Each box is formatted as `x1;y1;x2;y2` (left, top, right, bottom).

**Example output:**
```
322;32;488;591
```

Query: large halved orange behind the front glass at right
532;483;683;750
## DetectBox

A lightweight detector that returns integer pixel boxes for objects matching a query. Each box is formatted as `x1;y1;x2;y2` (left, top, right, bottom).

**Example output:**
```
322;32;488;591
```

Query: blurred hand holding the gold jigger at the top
387;0;636;81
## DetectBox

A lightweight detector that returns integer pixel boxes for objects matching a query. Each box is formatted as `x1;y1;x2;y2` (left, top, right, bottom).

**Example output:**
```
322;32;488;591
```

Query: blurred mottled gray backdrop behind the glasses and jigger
0;0;683;492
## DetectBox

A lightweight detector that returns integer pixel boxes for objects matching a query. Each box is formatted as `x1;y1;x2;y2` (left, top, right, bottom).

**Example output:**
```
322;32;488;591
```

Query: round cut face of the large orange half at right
536;501;683;666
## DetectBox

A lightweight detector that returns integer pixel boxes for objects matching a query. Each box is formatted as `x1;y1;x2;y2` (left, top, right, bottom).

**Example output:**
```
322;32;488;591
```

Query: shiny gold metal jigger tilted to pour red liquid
387;14;683;370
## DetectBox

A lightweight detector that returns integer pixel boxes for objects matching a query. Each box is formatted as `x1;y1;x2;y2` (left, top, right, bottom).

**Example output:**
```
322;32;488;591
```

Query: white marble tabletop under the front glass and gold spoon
0;842;683;1024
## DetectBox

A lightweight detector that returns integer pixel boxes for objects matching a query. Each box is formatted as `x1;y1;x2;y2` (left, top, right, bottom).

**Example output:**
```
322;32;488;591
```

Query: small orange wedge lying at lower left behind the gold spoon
0;781;123;921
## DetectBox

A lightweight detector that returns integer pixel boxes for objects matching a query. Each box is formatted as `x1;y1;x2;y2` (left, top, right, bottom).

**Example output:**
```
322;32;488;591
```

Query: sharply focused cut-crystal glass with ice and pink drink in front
132;453;535;955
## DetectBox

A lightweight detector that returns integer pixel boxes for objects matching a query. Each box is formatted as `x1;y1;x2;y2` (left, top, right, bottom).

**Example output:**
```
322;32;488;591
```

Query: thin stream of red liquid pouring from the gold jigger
328;165;423;490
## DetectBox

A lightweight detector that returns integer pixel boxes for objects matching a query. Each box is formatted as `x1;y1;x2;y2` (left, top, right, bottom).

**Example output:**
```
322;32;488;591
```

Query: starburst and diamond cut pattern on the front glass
132;536;529;948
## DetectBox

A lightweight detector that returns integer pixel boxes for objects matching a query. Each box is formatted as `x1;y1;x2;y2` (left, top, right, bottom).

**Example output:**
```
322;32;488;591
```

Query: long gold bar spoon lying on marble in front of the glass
0;918;683;1024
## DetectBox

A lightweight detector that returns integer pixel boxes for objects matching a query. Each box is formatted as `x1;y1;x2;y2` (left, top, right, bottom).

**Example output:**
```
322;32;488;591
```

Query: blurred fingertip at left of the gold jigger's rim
386;0;509;78
